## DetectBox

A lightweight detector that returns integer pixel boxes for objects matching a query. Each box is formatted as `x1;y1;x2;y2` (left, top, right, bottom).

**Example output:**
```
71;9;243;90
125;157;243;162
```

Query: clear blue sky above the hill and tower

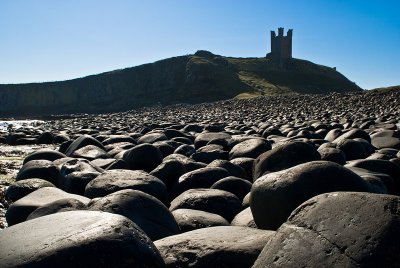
0;0;400;89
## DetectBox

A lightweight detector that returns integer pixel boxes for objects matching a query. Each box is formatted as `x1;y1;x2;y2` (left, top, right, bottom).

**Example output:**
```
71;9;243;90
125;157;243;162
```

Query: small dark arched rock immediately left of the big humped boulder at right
210;176;251;200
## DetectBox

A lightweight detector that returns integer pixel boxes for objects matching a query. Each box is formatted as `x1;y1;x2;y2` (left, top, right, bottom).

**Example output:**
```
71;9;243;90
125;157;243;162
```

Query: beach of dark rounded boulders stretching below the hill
0;89;400;267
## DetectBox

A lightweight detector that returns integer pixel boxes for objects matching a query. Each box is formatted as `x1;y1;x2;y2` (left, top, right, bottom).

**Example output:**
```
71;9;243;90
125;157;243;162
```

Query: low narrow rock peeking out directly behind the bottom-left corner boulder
26;198;87;220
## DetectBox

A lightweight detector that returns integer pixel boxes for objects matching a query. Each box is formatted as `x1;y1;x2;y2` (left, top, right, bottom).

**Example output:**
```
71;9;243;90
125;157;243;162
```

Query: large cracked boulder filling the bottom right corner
253;192;400;268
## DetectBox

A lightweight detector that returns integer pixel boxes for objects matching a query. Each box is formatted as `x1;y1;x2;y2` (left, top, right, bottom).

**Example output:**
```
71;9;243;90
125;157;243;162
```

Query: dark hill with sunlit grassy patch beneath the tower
0;51;361;117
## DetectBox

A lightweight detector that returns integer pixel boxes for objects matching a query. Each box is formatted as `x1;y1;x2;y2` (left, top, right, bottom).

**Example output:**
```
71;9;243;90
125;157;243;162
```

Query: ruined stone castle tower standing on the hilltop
267;28;293;64
